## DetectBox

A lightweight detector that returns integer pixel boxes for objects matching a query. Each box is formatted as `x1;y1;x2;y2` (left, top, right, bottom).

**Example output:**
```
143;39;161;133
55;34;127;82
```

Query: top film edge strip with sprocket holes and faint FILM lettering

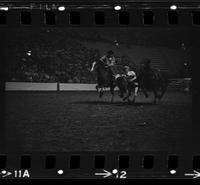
0;3;199;27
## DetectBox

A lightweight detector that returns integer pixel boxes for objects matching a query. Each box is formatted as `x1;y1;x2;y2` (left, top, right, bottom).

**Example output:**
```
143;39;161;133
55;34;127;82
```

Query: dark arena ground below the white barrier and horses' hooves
5;92;192;152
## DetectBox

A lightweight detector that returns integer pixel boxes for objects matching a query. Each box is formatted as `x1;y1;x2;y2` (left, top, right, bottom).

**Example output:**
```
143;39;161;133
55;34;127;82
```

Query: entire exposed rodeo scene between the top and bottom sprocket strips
6;28;192;152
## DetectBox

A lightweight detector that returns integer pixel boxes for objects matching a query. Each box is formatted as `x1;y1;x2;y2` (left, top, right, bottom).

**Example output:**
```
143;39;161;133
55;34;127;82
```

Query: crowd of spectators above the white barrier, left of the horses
6;30;100;83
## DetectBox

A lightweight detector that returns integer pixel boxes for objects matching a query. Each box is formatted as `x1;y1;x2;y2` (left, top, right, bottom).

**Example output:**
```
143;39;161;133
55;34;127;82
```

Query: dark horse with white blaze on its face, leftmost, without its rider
90;60;116;102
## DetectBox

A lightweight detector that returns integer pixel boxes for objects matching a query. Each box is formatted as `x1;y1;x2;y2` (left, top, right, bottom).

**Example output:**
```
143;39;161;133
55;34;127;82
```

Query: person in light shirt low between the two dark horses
124;66;139;96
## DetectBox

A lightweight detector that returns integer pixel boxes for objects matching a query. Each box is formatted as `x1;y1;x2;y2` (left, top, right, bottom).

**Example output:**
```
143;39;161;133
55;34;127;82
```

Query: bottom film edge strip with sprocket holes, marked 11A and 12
0;152;199;179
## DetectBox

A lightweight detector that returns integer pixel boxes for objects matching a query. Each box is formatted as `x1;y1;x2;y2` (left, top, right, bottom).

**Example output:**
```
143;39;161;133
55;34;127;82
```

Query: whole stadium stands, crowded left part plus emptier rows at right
6;28;190;83
